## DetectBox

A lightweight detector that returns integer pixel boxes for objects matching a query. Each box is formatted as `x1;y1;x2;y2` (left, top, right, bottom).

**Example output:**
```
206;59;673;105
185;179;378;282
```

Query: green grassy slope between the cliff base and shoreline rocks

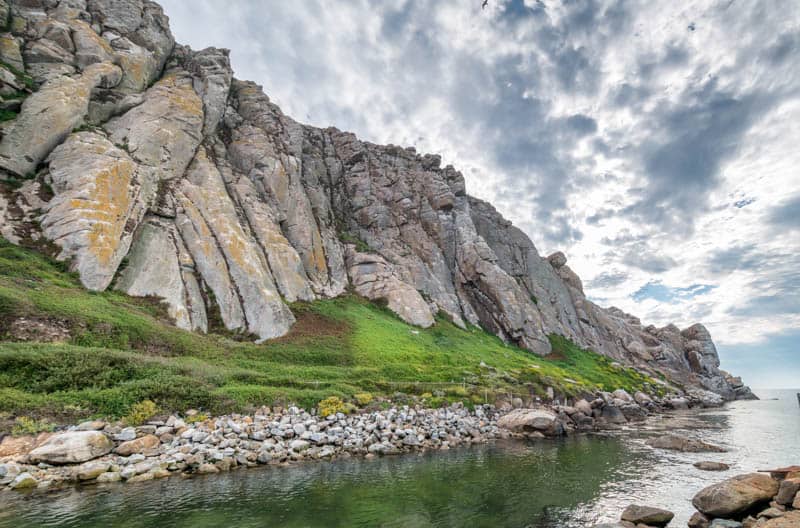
0;239;664;420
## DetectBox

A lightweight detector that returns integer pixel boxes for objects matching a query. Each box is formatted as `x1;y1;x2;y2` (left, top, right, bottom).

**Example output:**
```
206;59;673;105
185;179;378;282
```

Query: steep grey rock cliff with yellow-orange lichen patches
0;0;750;399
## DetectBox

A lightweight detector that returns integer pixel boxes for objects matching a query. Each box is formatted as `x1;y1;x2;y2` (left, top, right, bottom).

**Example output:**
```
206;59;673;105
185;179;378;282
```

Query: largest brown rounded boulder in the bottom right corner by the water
692;473;778;517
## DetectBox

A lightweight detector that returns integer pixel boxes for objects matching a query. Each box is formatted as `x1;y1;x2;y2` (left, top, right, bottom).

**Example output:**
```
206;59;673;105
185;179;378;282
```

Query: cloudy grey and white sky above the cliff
160;0;800;388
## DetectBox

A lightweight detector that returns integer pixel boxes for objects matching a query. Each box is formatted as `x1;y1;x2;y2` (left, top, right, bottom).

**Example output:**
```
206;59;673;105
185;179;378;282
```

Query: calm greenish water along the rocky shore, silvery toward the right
0;391;800;528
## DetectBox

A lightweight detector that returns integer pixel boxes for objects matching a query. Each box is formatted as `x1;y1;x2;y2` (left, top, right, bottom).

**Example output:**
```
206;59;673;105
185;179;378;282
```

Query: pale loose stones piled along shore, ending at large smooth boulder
0;404;509;489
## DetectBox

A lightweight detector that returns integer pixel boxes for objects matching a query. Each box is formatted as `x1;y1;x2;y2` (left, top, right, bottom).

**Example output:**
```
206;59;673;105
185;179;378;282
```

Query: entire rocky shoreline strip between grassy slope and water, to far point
0;390;740;491
